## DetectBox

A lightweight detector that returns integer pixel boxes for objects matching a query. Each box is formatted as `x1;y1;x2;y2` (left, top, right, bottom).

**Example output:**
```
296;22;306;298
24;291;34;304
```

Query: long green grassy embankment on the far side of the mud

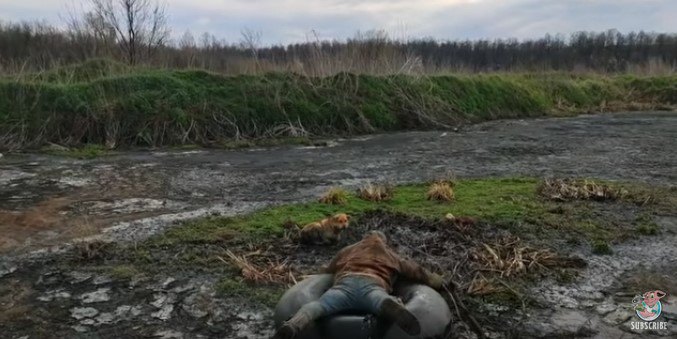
0;60;677;150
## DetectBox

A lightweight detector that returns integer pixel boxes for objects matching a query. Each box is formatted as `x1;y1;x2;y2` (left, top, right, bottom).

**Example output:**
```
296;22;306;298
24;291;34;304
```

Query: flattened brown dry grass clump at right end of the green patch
538;179;628;201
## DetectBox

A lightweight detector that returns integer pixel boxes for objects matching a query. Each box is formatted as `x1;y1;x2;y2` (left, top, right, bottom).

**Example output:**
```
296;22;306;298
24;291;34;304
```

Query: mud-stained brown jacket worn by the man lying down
327;235;431;292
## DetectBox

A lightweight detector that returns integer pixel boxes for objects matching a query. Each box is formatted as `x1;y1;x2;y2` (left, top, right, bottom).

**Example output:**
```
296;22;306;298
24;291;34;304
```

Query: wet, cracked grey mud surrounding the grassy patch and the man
0;112;677;338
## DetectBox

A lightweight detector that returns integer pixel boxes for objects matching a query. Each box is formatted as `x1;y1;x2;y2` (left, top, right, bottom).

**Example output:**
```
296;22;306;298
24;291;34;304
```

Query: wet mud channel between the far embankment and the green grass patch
0;112;677;253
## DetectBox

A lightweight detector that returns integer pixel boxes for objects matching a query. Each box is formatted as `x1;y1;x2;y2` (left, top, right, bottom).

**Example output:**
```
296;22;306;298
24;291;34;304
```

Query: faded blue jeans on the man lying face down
297;275;395;320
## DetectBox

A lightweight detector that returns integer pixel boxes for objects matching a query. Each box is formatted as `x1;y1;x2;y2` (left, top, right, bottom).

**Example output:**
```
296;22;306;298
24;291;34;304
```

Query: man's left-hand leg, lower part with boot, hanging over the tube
273;286;352;339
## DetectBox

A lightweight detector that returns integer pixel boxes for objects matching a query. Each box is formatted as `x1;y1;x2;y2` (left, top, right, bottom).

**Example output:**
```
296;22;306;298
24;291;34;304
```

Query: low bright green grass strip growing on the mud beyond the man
152;178;660;250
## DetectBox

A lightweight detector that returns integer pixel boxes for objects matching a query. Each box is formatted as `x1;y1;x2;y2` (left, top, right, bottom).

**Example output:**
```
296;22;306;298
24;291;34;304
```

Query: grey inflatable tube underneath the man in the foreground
274;274;451;339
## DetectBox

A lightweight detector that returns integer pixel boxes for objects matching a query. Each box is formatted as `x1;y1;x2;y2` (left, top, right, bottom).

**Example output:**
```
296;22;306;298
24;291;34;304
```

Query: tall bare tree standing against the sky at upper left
89;0;169;65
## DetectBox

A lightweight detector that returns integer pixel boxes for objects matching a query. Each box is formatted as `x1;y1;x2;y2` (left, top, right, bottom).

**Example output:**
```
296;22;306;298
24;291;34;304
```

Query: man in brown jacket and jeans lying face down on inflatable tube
273;231;444;339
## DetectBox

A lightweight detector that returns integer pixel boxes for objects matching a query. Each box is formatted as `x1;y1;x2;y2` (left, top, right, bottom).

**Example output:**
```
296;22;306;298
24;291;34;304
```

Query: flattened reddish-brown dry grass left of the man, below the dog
219;250;296;284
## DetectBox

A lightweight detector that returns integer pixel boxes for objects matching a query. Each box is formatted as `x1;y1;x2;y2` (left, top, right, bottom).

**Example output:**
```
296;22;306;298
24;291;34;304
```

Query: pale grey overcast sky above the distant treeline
0;0;677;44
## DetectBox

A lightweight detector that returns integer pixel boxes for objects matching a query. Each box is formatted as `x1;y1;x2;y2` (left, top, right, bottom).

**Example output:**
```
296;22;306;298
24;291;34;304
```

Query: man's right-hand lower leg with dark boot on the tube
366;286;421;335
